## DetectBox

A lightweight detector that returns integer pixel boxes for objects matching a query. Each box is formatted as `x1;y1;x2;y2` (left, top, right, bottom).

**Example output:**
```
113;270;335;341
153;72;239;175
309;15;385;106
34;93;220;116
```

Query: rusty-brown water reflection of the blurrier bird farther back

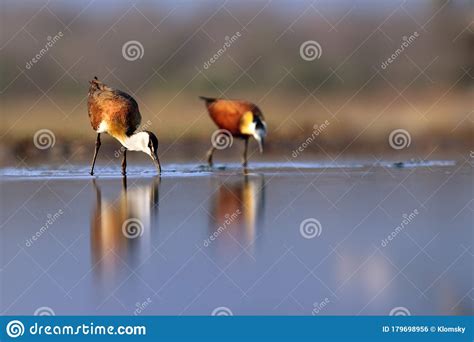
207;174;265;252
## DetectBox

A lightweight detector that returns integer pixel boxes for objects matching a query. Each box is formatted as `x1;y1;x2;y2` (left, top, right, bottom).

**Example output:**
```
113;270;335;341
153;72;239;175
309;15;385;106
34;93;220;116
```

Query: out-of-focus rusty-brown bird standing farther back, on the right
199;96;267;167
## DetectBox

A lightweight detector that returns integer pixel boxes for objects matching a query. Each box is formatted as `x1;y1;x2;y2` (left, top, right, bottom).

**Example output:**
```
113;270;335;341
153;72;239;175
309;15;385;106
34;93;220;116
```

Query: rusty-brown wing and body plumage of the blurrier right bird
207;99;255;136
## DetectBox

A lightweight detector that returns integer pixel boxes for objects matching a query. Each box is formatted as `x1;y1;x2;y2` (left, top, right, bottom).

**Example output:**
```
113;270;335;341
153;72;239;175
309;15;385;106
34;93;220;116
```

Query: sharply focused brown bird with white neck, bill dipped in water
87;77;161;175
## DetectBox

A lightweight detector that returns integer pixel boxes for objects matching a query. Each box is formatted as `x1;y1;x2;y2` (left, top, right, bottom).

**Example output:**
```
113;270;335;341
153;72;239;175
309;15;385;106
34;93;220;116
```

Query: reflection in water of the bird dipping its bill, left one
91;177;160;275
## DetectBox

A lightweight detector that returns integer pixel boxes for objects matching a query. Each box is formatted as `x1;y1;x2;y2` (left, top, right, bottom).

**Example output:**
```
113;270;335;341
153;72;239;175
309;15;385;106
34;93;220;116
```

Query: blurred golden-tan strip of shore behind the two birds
0;90;474;165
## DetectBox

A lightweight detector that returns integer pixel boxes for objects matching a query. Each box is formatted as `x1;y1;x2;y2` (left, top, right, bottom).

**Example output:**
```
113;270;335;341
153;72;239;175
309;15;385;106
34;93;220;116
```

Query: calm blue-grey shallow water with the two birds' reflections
0;161;474;315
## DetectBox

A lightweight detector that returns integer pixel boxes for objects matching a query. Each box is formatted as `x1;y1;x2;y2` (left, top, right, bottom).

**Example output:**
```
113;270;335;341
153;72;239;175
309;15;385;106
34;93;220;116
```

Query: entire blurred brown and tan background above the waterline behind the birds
0;0;474;167
